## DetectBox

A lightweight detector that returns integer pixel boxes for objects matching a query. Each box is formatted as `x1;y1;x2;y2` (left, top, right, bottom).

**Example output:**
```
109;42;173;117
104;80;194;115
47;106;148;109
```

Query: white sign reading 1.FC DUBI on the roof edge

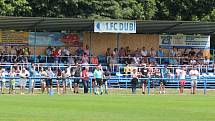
94;20;136;33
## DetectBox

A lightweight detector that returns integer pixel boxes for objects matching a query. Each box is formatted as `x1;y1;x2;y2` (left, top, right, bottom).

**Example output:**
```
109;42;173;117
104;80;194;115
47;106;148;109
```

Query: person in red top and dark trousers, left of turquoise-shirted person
82;67;90;93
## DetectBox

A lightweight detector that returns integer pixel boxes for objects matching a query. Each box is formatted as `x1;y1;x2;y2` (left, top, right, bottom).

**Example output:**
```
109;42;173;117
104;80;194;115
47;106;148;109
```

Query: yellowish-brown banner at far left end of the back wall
0;31;29;46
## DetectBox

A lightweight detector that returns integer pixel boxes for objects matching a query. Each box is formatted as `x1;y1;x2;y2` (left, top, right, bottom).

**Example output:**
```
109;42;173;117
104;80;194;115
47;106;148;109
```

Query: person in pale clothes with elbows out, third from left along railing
19;67;30;94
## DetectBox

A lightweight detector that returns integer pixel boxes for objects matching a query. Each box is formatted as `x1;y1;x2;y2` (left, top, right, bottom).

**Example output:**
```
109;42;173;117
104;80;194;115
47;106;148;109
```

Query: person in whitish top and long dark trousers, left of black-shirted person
131;68;138;94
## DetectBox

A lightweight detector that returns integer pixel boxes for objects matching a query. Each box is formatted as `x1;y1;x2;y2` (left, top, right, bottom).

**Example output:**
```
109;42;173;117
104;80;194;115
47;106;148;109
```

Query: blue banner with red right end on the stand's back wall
29;32;83;47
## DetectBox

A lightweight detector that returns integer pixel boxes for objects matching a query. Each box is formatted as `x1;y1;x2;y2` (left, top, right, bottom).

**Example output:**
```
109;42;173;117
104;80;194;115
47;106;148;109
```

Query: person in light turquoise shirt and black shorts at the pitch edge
94;65;103;95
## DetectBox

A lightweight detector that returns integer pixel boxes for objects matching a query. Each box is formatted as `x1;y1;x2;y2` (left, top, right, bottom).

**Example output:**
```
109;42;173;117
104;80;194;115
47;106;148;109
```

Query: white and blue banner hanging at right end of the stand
159;35;210;49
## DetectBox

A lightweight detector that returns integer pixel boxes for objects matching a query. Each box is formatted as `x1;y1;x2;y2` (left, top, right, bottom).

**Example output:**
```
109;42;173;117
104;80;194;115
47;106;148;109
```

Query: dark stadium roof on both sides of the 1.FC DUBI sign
0;16;215;34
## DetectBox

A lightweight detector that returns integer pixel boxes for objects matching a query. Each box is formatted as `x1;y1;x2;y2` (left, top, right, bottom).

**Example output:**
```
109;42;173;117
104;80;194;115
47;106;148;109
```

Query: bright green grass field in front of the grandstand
0;94;215;121
